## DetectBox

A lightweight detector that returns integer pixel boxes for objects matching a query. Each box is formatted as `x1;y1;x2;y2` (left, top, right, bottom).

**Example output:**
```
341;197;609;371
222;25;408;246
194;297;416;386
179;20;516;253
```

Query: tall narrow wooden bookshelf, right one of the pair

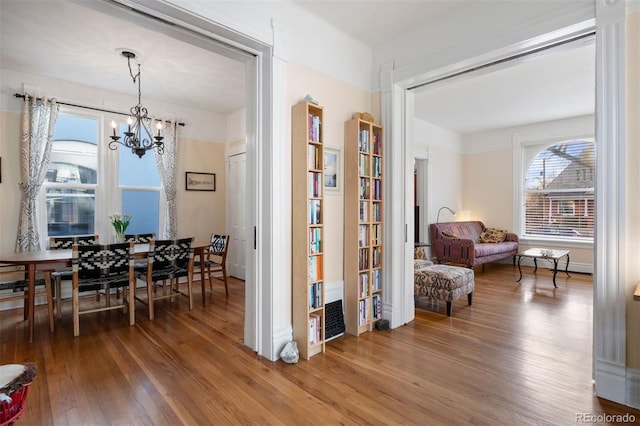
344;118;384;336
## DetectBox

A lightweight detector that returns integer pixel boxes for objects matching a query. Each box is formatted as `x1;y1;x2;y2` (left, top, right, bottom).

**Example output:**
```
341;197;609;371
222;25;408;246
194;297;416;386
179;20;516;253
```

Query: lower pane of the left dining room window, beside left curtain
46;188;95;237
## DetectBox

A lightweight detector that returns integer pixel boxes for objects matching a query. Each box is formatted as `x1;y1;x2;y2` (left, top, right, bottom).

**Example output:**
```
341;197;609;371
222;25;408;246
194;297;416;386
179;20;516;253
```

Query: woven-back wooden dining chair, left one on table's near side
71;242;136;337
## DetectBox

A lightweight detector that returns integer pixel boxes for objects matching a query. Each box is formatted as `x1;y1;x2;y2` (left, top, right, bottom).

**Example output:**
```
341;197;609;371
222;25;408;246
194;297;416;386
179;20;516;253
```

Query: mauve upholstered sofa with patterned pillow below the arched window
429;221;519;268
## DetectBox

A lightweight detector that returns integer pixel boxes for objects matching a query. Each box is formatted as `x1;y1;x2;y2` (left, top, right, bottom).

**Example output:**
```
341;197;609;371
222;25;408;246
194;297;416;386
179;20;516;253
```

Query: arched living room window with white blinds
522;139;596;239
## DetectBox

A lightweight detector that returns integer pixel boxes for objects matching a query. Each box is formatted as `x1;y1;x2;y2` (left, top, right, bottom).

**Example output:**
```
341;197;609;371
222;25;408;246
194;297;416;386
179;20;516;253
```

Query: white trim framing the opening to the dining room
111;0;282;360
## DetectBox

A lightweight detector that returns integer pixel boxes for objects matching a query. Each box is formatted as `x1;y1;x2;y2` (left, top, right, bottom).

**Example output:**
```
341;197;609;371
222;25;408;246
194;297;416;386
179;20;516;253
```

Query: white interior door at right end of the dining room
227;153;247;280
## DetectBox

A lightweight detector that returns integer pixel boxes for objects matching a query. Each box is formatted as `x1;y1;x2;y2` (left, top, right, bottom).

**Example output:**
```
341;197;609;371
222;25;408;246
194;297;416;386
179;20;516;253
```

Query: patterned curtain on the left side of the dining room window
16;96;58;252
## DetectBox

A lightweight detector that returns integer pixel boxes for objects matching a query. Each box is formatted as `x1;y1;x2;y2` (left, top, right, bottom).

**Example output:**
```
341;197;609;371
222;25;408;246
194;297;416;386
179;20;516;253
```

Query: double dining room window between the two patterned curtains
40;109;163;246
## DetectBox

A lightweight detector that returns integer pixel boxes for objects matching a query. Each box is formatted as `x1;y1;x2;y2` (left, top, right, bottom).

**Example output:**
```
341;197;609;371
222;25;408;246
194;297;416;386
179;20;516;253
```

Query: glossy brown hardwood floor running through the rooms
0;264;640;425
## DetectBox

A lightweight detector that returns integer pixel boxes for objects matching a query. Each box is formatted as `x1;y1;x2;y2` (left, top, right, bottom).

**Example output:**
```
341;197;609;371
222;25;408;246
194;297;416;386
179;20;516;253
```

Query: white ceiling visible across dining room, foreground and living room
0;0;595;134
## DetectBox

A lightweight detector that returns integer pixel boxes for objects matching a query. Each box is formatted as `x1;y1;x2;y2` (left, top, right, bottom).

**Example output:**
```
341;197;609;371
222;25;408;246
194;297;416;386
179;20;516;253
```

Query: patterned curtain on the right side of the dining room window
155;121;178;240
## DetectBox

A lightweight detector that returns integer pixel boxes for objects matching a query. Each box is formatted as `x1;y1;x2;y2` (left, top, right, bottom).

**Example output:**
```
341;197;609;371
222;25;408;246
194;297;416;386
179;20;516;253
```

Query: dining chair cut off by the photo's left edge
0;265;55;331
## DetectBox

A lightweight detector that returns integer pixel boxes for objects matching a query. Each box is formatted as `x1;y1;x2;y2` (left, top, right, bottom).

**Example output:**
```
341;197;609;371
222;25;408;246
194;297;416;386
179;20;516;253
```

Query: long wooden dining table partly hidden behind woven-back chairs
0;241;211;342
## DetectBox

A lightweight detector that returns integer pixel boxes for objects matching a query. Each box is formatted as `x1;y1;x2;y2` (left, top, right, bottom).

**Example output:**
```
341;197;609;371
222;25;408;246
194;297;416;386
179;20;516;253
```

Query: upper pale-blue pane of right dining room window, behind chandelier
118;124;160;185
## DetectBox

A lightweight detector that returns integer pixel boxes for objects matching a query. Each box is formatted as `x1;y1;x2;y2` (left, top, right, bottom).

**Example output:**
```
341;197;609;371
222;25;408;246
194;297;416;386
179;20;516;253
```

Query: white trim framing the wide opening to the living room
381;1;640;406
